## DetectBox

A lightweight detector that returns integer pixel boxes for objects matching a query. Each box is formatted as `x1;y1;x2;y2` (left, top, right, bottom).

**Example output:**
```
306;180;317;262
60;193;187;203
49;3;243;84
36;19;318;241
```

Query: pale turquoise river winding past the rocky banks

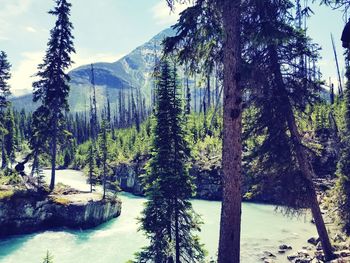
0;170;316;263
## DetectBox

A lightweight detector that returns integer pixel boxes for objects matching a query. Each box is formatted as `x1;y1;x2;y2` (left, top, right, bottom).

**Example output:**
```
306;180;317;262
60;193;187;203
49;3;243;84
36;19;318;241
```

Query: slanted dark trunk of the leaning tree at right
269;47;334;261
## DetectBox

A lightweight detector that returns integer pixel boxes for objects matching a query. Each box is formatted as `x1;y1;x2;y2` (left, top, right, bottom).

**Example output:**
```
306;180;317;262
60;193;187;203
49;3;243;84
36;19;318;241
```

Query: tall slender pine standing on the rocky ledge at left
33;0;75;190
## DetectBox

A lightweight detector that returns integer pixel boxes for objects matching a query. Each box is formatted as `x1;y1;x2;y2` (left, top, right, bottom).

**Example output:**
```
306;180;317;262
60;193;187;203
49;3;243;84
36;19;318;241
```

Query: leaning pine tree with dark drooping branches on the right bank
241;0;333;260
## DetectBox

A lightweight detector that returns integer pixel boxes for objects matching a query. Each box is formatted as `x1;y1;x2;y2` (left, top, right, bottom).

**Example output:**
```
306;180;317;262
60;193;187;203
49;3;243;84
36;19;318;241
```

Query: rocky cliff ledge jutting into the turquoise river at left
0;192;121;236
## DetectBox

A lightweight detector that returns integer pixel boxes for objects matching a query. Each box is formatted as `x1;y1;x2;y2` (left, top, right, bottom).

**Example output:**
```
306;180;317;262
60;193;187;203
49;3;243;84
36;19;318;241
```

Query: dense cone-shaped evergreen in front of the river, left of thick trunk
137;61;204;263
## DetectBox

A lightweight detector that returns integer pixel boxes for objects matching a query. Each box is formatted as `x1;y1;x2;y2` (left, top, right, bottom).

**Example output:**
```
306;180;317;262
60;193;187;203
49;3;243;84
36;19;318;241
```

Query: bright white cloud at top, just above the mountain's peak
152;0;189;26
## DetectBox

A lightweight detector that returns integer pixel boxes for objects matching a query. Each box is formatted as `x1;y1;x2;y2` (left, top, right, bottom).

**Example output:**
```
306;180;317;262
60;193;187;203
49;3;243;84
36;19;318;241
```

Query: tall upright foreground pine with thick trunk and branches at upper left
165;0;243;263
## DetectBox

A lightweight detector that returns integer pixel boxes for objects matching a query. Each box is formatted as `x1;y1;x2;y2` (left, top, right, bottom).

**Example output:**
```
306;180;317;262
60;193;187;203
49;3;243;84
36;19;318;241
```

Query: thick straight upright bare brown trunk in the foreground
218;0;242;263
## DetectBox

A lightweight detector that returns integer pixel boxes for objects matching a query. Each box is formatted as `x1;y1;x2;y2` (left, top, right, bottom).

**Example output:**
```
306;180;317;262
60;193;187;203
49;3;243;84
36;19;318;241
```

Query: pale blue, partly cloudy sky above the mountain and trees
0;0;344;95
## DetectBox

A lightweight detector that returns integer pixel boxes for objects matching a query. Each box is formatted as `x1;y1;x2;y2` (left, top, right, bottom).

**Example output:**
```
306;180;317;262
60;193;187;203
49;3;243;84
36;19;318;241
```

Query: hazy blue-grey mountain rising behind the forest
11;28;174;112
